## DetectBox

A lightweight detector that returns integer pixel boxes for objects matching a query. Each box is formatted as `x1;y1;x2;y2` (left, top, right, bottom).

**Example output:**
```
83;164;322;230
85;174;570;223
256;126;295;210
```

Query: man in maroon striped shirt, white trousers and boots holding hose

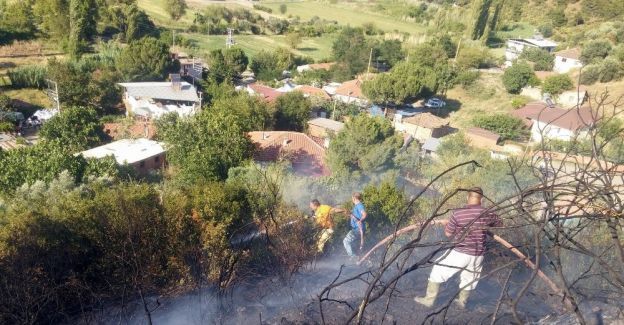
414;187;502;308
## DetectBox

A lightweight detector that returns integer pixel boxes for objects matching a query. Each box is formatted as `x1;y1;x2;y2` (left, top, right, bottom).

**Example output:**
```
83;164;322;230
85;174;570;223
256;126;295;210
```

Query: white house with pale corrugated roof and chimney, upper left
119;75;201;119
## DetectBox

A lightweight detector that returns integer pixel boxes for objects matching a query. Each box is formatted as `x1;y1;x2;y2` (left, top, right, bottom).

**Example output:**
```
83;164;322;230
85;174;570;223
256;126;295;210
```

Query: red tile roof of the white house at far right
512;102;595;131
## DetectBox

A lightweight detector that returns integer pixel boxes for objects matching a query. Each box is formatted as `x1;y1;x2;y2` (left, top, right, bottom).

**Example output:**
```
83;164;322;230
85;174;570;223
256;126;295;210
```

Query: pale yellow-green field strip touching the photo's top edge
262;1;425;34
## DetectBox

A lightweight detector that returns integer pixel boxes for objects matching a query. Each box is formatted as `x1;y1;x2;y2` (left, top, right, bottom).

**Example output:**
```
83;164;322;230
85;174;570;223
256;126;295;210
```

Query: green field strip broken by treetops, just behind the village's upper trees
183;34;334;61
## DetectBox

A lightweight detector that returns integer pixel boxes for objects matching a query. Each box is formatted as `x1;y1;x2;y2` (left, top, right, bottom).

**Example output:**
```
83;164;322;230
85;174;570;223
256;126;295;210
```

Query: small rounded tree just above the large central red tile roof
275;91;312;132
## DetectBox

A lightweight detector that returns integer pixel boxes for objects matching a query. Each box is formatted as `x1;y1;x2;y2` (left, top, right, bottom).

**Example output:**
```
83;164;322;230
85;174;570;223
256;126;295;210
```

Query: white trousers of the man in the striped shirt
429;249;483;290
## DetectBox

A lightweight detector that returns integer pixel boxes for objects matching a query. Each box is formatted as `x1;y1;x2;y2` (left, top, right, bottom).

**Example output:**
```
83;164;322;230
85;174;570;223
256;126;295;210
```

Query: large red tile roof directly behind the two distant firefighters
248;131;329;177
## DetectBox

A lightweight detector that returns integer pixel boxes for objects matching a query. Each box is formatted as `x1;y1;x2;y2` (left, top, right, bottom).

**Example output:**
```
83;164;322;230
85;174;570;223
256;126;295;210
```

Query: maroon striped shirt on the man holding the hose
446;204;503;256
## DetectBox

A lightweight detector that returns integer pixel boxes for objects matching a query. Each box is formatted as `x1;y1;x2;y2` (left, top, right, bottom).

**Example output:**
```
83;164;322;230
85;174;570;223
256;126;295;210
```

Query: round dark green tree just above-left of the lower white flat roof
40;107;104;151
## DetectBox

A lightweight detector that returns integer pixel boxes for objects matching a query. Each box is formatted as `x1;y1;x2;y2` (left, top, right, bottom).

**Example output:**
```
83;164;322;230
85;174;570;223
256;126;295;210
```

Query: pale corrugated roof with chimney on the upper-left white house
119;81;199;102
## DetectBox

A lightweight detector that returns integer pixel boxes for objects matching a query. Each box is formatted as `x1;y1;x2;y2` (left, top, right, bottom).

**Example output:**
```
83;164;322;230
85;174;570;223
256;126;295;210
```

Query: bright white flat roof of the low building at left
80;138;165;165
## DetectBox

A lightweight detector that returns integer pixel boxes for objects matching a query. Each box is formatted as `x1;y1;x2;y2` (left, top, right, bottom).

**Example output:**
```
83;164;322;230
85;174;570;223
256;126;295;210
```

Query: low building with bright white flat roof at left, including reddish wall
79;138;165;175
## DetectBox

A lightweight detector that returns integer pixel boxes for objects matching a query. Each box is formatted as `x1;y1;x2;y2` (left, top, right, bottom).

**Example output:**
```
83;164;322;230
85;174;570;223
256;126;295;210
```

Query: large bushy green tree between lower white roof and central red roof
158;110;253;183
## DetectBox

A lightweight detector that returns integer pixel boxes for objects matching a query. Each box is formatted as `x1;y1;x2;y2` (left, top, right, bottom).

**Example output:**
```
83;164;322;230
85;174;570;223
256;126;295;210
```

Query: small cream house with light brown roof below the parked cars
393;113;453;143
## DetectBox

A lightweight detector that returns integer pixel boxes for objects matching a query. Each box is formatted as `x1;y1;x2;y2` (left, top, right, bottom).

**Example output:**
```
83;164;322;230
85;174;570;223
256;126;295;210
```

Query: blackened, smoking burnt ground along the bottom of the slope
89;228;617;325
